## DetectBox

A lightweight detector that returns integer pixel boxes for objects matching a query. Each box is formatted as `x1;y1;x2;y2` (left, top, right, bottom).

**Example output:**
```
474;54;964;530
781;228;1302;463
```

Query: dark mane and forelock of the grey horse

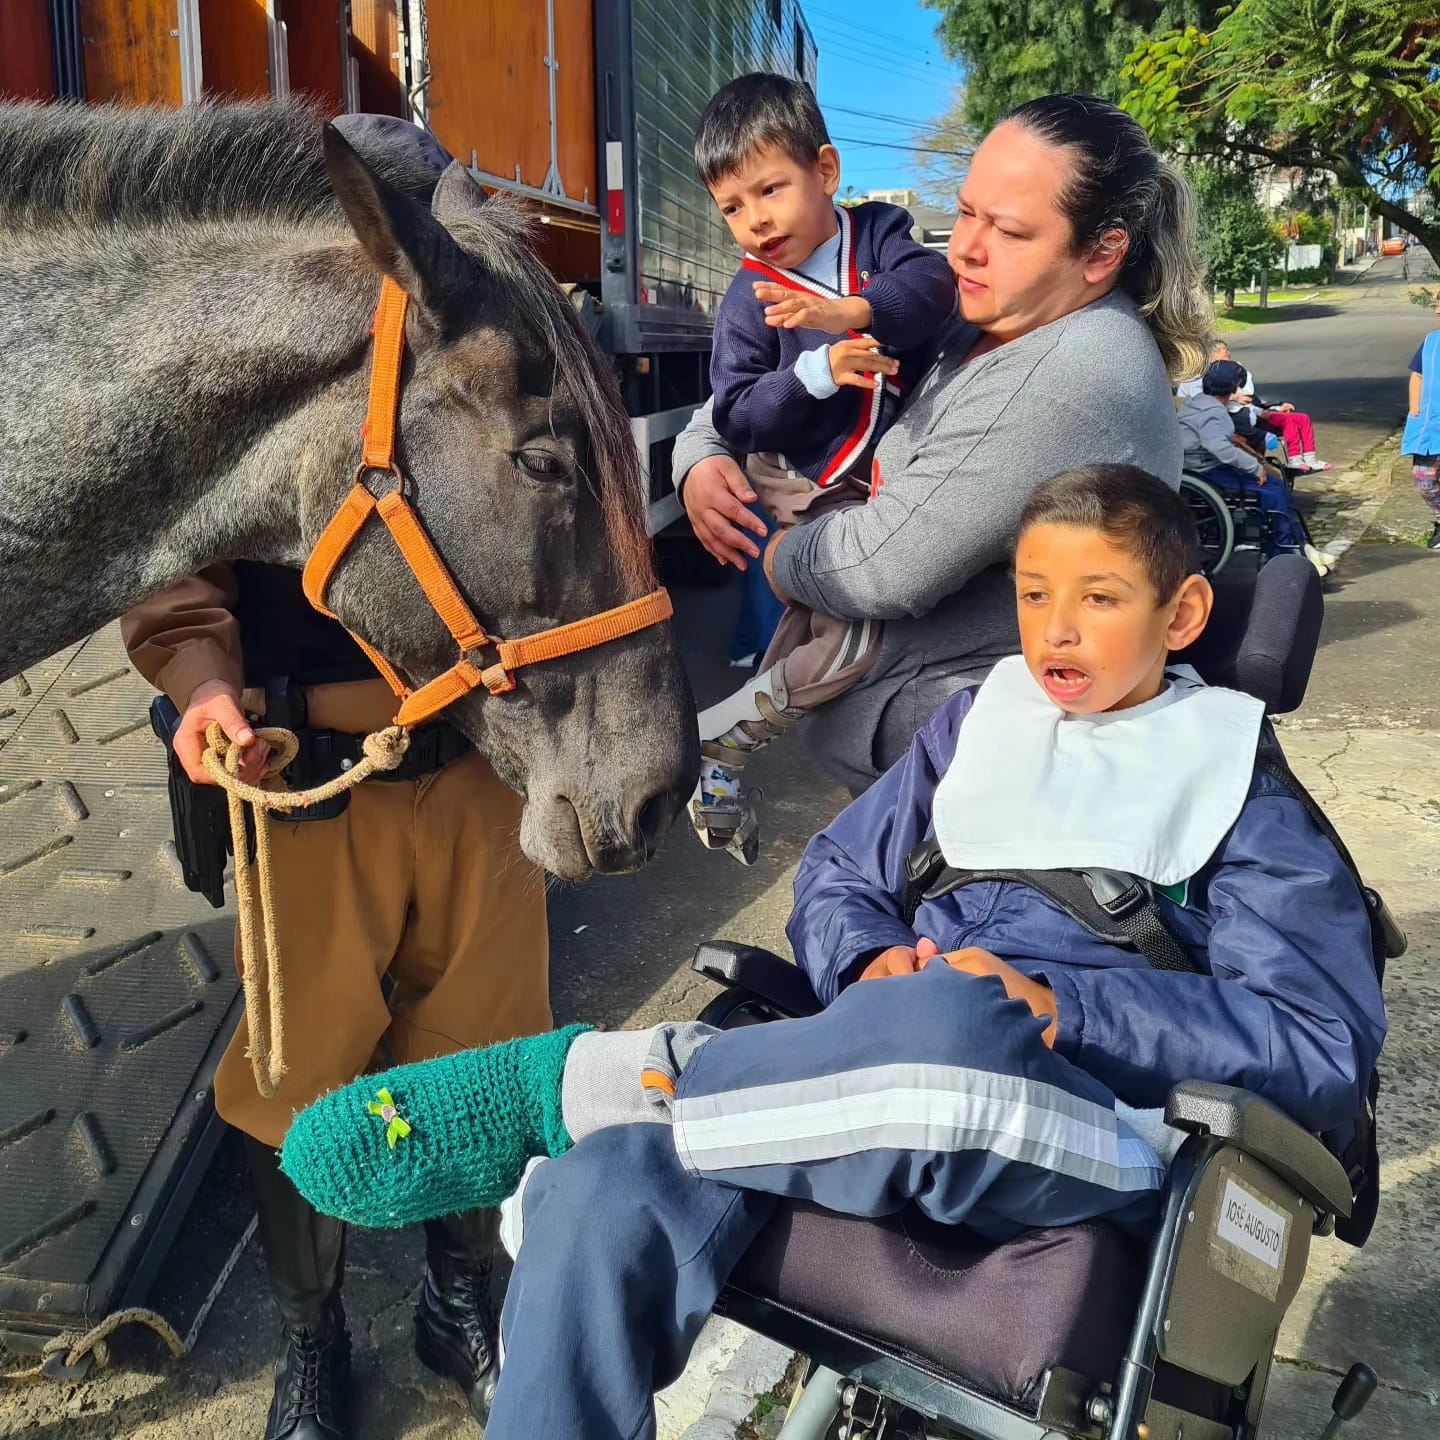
0;101;654;593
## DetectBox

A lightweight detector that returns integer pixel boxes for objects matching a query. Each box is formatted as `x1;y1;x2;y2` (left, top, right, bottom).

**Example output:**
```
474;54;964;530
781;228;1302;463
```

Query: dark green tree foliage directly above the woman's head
924;0;1220;135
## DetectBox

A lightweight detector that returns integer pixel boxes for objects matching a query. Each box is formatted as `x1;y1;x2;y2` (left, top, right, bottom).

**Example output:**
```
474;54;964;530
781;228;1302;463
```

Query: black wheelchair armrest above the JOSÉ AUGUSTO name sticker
1165;1080;1354;1218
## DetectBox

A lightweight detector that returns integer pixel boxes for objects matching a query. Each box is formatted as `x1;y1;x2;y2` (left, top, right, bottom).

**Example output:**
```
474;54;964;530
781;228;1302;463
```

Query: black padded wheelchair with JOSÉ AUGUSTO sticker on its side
693;556;1405;1440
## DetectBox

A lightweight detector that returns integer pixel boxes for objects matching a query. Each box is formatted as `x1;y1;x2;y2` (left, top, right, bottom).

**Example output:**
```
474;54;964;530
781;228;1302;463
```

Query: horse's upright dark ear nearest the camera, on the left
324;124;467;321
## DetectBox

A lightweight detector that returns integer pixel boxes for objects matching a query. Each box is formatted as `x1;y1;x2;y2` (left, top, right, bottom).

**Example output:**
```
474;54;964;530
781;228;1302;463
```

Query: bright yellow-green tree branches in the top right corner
1122;0;1440;259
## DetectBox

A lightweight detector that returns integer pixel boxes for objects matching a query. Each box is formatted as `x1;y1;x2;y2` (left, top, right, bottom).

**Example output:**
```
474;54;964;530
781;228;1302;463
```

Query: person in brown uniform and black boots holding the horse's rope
121;552;552;1440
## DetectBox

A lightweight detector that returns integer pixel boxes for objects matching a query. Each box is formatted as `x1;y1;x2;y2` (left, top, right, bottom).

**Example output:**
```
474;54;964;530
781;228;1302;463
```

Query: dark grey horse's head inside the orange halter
312;127;700;880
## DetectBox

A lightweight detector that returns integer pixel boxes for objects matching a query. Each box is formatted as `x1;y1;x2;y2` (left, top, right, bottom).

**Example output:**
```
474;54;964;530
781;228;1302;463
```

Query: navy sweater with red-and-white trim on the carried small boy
710;203;956;485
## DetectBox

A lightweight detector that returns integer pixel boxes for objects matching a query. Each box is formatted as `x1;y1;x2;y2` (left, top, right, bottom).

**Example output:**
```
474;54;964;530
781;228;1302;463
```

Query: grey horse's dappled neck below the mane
0;226;377;675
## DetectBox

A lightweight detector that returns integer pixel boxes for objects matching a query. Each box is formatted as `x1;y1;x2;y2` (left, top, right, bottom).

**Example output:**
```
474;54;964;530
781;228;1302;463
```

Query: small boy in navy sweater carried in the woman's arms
691;75;955;864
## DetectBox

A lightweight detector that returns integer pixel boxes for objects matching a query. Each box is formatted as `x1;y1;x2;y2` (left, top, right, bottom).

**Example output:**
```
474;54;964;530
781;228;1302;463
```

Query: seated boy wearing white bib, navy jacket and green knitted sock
282;465;1385;1440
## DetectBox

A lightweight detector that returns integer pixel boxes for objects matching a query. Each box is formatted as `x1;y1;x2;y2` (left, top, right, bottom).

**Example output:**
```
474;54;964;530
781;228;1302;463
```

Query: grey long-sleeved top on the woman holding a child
674;294;1181;791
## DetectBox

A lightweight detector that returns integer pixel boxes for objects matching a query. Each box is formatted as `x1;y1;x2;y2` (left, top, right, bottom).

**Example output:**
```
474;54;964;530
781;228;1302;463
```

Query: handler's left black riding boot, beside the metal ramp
245;1136;350;1440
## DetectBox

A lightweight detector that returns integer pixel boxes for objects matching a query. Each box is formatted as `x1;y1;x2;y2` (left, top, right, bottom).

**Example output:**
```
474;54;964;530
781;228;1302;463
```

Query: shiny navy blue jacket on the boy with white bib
788;690;1385;1132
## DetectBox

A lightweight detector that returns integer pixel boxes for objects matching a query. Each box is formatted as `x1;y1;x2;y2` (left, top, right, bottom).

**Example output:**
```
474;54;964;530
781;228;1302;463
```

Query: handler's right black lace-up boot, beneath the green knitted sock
415;1210;500;1424
